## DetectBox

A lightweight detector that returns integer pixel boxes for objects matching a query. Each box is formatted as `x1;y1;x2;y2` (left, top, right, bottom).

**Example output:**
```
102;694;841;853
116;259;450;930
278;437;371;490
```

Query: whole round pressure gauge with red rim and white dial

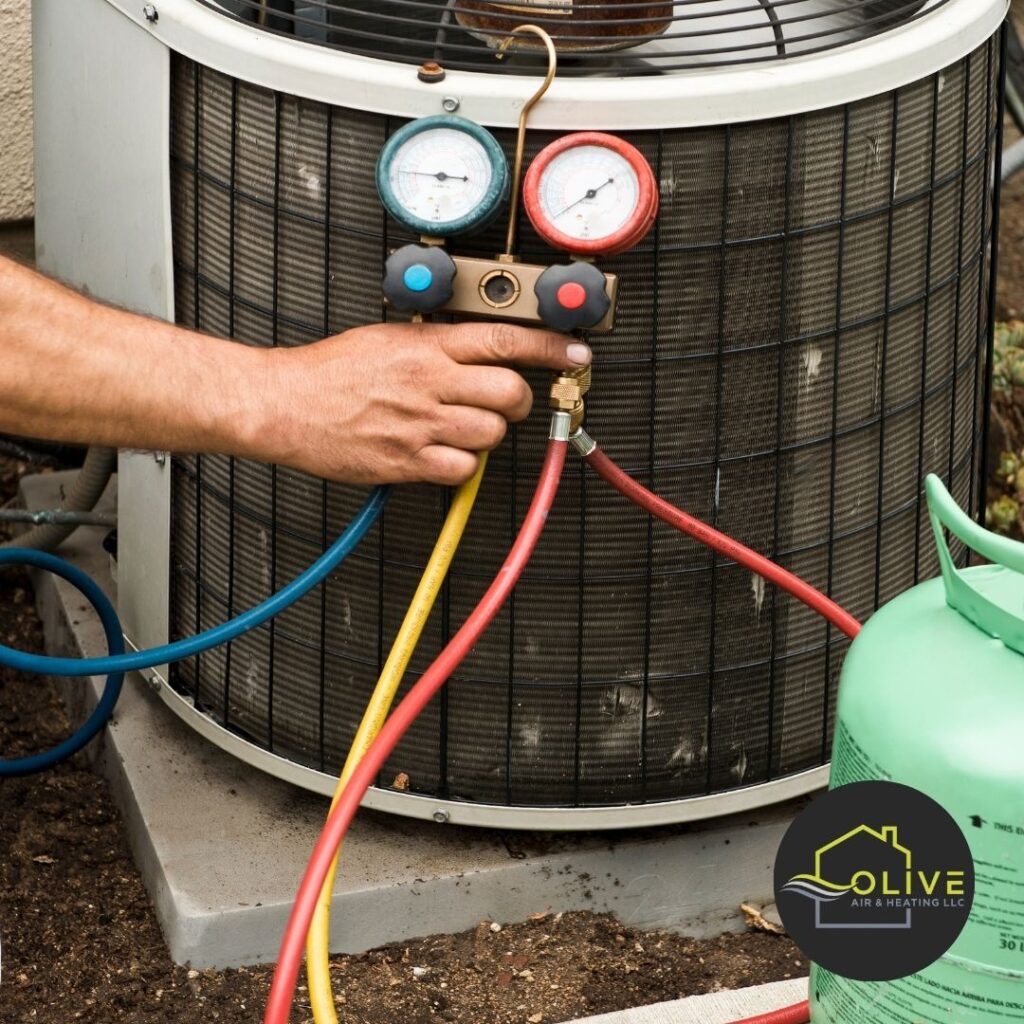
523;131;657;256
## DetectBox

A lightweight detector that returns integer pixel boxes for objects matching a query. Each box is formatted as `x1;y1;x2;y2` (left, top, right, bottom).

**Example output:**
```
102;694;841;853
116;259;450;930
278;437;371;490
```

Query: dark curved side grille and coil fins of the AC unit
170;40;999;824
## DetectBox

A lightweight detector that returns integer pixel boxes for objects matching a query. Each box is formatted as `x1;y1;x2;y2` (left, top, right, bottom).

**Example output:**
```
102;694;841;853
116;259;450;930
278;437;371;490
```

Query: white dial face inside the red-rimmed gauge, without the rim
539;145;640;242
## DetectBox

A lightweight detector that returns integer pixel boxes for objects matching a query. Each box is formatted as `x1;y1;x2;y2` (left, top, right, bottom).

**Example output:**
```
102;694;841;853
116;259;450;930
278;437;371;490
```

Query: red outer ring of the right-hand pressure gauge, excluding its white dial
522;131;658;256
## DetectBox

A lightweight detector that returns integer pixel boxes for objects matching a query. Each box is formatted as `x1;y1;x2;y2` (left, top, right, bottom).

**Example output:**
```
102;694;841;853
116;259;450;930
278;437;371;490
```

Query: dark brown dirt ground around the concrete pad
9;24;1024;1024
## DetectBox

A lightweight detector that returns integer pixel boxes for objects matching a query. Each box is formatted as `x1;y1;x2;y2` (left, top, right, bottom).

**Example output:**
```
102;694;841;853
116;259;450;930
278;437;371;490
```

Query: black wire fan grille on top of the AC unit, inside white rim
201;0;948;75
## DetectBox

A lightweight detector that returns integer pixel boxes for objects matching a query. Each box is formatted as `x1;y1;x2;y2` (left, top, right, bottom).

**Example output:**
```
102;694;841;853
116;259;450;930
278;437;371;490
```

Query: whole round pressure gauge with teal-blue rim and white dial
377;114;509;239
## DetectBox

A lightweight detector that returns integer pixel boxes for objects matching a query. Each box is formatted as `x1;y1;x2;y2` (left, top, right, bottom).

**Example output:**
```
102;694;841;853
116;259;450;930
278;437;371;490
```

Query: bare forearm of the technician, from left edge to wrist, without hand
0;257;268;454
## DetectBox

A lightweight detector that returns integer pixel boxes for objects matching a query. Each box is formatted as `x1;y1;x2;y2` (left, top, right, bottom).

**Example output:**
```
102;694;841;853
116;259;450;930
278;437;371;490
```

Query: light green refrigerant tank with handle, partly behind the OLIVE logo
810;476;1024;1024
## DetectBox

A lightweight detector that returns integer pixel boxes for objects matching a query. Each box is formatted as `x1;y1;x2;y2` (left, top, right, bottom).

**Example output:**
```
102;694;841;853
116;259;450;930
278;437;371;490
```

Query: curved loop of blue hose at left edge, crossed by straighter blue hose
0;548;125;778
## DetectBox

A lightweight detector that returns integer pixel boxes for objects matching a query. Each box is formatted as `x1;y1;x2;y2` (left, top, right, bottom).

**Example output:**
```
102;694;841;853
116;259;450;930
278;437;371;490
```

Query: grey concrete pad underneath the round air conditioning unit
14;474;803;968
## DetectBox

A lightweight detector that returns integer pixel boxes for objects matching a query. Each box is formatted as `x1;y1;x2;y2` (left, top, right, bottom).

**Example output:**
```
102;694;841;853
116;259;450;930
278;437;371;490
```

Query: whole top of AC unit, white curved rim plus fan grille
108;0;1009;129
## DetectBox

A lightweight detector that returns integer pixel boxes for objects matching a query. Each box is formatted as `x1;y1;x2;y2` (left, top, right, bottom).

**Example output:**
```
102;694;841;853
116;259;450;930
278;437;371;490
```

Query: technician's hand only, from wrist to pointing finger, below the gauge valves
258;324;591;484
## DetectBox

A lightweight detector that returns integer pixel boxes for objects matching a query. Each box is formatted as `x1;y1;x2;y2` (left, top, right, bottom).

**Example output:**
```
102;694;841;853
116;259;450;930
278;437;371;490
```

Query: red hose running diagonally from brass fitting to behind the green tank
573;434;860;637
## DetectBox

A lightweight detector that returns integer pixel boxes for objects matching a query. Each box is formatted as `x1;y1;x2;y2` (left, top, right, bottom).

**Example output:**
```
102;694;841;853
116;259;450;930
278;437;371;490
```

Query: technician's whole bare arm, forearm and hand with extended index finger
0;257;590;484
